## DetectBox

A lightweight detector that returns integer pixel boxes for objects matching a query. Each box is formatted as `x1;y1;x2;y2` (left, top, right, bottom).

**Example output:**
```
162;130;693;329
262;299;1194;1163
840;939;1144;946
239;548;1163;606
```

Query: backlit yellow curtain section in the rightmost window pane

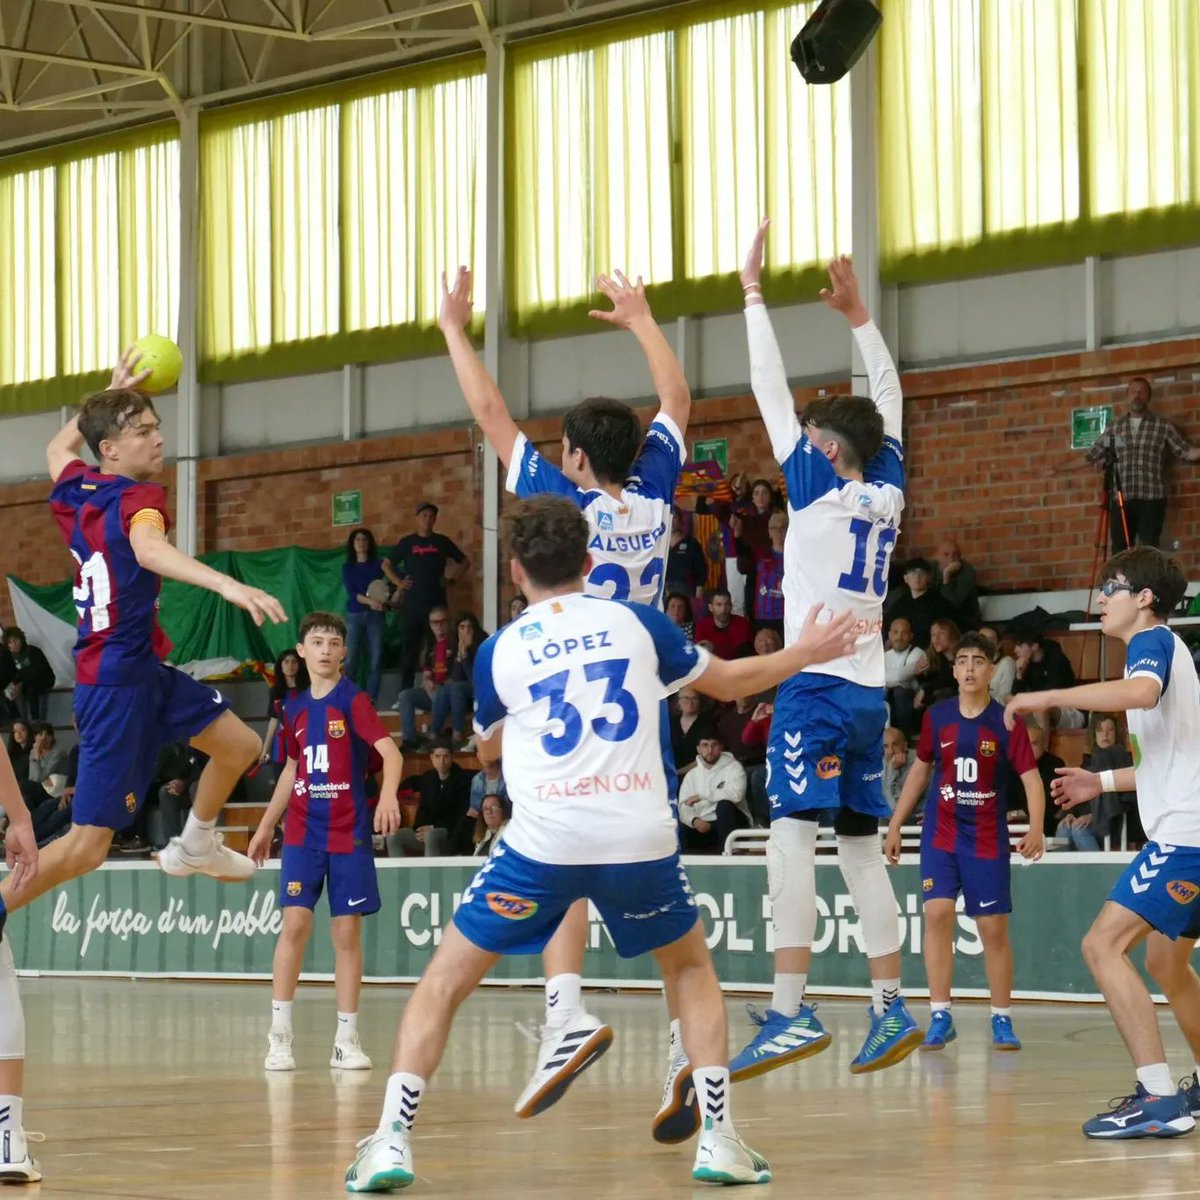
1084;0;1200;216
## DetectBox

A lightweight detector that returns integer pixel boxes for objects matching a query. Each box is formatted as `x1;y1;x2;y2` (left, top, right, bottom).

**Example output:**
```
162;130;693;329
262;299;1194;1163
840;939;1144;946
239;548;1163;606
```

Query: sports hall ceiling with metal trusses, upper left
0;0;668;154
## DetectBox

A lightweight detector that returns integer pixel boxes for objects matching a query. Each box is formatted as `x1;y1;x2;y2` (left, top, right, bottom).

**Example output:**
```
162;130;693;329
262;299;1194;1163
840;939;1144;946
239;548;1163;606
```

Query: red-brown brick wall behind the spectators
0;340;1200;620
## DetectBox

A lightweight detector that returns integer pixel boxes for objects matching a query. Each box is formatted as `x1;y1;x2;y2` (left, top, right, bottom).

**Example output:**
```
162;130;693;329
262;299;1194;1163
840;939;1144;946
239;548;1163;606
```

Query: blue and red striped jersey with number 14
283;678;388;854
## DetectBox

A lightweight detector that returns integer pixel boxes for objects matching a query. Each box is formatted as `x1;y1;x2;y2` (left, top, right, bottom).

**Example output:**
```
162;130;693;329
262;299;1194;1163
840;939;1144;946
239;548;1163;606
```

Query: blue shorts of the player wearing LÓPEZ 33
454;845;700;959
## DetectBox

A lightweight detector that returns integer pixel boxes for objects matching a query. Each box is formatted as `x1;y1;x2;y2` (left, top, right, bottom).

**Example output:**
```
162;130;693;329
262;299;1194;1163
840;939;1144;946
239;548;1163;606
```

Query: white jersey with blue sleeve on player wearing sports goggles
1126;625;1200;847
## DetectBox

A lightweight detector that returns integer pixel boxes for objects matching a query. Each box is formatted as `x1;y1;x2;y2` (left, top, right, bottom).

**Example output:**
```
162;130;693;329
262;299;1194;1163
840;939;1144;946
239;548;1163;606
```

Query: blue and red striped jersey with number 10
917;696;1038;858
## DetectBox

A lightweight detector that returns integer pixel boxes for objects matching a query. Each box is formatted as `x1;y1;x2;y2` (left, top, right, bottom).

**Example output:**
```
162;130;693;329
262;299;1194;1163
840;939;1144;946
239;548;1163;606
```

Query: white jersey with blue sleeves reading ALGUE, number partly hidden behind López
506;413;686;606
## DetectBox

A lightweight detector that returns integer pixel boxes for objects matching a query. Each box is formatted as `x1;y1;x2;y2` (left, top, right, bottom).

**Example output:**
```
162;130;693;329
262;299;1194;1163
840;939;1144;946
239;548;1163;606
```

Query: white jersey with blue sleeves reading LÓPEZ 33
475;593;708;865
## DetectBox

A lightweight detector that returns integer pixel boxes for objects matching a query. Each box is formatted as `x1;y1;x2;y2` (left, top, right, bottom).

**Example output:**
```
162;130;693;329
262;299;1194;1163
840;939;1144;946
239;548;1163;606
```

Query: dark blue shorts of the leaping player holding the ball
71;662;229;829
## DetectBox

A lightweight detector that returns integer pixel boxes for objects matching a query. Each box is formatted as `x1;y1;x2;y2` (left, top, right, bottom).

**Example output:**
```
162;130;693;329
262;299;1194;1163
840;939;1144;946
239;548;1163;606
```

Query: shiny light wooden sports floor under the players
16;978;1200;1200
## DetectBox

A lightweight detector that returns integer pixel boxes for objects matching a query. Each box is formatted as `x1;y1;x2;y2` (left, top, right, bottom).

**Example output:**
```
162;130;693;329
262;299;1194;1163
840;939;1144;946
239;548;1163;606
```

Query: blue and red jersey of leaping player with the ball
50;458;170;684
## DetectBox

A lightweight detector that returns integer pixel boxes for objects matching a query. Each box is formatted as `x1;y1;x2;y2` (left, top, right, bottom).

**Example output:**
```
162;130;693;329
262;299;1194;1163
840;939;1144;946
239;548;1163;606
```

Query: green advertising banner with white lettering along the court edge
6;854;1128;1000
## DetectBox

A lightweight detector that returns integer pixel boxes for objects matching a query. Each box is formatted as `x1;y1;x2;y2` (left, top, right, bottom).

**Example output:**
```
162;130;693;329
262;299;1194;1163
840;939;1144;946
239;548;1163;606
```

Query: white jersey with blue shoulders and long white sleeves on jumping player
746;305;904;688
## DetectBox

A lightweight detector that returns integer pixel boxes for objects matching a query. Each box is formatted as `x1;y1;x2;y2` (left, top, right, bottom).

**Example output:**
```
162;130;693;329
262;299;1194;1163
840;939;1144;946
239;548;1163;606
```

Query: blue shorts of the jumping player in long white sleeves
767;674;892;821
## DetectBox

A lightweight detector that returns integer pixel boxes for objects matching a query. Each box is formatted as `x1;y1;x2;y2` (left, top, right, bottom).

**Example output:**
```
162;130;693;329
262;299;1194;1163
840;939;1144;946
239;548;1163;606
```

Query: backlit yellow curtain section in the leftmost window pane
0;167;56;386
